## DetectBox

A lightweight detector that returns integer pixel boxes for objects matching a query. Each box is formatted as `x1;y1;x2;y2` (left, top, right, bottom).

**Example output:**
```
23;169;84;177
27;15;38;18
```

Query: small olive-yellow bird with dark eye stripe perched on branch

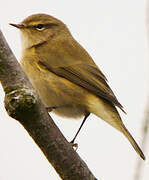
11;14;145;159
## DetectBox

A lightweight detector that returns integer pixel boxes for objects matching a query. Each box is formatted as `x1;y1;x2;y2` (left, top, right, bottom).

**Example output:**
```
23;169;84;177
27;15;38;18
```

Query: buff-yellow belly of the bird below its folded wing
23;61;88;118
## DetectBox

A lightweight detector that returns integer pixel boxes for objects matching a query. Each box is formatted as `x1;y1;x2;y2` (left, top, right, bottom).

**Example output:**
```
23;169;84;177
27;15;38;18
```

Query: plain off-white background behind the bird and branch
0;0;149;180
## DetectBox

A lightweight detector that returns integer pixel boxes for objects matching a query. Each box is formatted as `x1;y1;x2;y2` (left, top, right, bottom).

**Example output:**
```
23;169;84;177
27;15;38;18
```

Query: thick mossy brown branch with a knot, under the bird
0;31;97;180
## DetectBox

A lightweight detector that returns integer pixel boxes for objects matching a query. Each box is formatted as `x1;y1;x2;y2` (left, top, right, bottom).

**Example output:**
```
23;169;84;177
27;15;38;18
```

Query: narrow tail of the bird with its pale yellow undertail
88;96;145;160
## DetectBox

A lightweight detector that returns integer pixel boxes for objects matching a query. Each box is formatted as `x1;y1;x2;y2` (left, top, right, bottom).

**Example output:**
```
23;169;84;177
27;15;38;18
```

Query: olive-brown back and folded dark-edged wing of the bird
36;38;125;112
